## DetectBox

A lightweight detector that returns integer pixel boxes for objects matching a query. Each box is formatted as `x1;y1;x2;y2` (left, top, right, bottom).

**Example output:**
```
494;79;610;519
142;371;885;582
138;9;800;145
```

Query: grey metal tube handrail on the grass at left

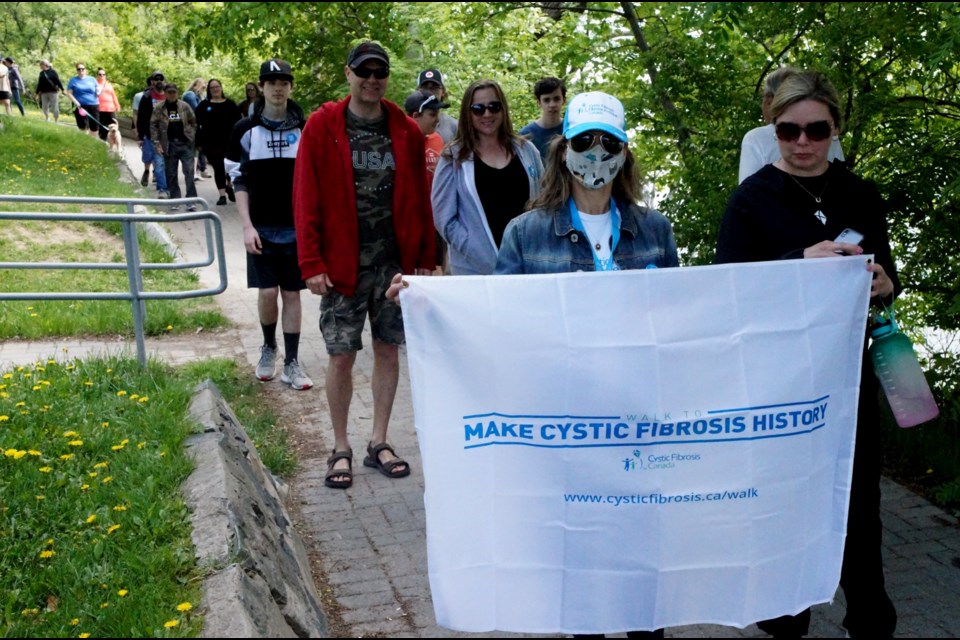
0;195;227;365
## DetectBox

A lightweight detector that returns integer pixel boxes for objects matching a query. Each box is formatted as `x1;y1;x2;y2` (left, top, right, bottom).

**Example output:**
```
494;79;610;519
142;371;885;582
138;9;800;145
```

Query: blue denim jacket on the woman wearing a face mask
494;202;680;274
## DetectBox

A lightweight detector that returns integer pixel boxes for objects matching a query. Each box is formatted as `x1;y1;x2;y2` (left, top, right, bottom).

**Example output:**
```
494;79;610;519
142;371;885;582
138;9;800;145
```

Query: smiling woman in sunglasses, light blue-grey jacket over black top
431;80;543;275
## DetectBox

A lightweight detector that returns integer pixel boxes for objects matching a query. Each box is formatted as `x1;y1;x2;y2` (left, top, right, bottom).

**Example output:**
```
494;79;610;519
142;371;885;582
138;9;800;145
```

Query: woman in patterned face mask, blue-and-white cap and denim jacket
495;91;679;273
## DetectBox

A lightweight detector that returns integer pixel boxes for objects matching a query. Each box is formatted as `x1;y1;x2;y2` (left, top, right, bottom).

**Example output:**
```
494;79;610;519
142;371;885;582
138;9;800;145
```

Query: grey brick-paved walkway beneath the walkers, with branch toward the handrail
0;134;960;638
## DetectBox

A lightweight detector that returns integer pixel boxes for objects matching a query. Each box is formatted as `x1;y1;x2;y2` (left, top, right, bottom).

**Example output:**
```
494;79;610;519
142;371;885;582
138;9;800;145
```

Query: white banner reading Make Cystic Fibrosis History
401;257;870;633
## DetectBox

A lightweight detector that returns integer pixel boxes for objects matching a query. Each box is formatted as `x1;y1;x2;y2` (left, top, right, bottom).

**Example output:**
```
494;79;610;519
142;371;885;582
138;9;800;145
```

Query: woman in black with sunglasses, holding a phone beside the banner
716;71;900;638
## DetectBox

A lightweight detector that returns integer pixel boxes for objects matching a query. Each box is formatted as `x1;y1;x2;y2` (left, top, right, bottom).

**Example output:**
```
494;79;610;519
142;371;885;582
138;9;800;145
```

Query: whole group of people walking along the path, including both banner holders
7;41;900;637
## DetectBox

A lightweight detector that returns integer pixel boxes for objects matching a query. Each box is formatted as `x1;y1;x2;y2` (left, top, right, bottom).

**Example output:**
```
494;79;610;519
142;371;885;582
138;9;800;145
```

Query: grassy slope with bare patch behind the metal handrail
0;116;228;339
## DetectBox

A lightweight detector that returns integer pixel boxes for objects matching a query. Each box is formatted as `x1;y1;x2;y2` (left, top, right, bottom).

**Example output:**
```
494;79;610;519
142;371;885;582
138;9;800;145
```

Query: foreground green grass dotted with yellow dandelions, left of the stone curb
0;360;200;637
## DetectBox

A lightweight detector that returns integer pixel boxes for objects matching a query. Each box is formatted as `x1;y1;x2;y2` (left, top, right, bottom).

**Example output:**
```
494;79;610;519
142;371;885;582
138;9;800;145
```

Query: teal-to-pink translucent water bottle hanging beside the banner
861;312;940;427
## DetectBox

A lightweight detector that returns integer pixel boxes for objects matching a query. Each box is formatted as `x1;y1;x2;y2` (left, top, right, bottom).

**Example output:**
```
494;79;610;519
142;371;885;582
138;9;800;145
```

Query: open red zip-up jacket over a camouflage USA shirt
293;96;436;296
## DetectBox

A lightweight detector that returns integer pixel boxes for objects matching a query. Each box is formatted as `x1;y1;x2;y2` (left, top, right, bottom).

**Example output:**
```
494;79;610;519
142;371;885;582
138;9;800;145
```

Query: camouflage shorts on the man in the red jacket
320;265;404;355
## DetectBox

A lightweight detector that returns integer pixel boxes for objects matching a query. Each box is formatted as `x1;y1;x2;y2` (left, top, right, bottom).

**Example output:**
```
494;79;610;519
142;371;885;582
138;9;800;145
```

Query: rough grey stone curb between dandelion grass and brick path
181;380;328;638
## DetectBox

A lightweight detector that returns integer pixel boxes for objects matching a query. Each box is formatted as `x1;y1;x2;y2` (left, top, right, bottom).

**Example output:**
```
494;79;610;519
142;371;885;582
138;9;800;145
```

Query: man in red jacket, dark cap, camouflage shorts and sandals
293;41;436;489
